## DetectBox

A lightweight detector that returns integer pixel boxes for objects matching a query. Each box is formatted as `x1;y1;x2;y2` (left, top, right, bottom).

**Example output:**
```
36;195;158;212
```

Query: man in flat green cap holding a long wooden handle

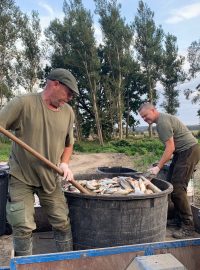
0;68;79;256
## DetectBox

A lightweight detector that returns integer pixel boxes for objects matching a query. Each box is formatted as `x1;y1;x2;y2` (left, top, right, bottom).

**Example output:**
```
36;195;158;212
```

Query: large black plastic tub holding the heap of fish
65;174;173;250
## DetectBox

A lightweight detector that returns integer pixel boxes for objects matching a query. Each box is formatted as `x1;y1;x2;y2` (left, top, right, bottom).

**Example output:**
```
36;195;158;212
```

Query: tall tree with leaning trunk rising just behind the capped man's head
48;0;103;145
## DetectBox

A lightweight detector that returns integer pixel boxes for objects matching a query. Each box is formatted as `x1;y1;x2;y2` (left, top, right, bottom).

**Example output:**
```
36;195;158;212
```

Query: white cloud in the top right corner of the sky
165;3;200;24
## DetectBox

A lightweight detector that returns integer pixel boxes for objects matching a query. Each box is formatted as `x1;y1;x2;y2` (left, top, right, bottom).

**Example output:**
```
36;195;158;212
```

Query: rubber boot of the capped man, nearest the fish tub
53;229;73;252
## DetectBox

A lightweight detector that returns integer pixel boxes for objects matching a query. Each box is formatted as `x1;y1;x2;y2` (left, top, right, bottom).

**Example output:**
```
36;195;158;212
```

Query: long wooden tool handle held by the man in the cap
0;126;90;194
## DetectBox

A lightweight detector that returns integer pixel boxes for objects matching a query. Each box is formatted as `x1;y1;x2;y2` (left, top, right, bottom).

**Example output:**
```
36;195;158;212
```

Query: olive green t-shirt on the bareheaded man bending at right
156;113;197;152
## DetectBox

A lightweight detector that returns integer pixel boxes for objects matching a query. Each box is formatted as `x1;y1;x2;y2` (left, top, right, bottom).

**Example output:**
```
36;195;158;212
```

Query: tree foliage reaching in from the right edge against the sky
185;40;200;119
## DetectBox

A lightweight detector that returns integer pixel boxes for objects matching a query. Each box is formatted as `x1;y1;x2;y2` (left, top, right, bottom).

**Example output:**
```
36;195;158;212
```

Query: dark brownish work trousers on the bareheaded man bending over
167;144;200;225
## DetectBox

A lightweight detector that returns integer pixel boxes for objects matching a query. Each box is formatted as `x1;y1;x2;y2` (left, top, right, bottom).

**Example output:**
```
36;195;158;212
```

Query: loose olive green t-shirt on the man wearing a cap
0;93;74;193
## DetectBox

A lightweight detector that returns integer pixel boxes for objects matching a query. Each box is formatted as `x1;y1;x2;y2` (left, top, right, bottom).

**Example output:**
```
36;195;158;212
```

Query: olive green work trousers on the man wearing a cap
6;176;71;237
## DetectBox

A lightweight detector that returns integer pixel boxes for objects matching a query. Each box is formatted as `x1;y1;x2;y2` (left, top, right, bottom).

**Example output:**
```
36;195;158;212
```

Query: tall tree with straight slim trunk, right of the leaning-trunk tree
95;0;133;139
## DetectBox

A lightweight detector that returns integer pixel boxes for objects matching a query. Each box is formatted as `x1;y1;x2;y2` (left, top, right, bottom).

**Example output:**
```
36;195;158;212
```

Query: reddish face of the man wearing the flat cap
51;81;73;108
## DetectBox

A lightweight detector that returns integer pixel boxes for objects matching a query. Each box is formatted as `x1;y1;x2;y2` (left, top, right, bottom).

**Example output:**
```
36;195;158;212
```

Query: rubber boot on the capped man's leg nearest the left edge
13;235;33;256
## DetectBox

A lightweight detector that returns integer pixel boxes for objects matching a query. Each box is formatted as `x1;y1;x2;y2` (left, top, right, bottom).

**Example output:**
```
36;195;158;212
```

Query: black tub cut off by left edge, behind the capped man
0;167;8;235
